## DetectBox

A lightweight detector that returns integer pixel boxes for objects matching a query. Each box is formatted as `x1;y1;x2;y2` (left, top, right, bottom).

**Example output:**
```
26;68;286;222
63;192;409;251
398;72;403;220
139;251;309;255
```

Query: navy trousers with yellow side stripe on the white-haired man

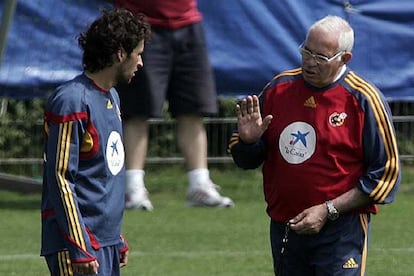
270;214;370;276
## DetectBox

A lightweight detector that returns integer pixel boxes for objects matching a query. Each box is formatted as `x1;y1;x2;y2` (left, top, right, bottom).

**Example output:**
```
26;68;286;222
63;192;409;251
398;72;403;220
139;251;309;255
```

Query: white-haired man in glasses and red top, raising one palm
229;16;401;276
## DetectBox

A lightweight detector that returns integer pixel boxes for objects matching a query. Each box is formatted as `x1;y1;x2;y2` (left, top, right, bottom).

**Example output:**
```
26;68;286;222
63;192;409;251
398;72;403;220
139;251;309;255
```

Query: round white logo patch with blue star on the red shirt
279;122;316;164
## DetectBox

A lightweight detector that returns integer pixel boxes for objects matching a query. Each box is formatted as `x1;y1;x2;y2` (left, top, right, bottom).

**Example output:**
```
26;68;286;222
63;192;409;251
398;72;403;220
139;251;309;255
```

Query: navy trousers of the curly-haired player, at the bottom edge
45;245;121;276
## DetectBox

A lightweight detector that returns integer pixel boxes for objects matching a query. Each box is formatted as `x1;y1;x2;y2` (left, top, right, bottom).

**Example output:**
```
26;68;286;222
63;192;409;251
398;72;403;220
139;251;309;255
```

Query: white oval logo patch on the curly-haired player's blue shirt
106;131;125;175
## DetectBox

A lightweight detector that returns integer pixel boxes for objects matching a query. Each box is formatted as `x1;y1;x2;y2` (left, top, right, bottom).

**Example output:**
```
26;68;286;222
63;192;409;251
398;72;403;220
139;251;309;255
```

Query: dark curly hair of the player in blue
78;8;151;72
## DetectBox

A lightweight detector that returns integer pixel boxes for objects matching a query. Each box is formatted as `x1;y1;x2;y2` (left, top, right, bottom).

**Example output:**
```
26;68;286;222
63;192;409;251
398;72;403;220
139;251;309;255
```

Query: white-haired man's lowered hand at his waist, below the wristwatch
289;203;328;235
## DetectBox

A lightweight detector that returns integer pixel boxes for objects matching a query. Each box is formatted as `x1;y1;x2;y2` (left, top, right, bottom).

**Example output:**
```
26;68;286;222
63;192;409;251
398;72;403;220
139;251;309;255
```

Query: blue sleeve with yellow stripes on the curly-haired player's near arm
45;93;95;263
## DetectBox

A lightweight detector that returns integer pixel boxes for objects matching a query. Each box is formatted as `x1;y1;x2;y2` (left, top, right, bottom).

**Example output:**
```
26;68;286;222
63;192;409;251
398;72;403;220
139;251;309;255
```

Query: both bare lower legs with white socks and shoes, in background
124;112;234;211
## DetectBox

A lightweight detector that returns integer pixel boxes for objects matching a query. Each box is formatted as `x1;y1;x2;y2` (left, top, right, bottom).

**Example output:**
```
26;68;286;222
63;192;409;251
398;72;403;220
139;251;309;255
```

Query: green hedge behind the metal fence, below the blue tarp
0;97;414;177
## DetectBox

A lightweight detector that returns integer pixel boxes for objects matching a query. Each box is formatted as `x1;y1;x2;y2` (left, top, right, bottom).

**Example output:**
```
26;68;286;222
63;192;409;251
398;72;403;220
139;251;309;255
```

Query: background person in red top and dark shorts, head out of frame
112;0;233;211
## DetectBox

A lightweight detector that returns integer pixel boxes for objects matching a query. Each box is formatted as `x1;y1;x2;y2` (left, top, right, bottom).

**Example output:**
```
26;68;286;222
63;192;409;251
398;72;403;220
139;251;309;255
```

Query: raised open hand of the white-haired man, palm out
236;95;273;144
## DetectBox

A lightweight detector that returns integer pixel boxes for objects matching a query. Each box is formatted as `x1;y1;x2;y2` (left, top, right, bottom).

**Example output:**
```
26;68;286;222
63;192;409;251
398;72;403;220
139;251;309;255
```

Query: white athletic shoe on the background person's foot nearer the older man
186;180;234;207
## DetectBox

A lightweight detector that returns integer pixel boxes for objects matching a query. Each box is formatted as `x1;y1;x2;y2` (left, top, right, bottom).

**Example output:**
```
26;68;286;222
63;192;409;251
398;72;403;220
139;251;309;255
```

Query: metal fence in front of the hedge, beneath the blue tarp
0;103;414;178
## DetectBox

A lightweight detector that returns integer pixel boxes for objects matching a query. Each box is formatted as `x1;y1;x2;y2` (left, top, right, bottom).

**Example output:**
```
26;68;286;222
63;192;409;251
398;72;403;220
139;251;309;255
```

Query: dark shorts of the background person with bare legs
116;23;217;119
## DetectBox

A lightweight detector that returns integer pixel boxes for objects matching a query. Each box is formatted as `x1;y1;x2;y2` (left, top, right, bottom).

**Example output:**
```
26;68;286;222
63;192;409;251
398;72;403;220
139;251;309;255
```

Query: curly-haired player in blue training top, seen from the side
41;9;150;276
